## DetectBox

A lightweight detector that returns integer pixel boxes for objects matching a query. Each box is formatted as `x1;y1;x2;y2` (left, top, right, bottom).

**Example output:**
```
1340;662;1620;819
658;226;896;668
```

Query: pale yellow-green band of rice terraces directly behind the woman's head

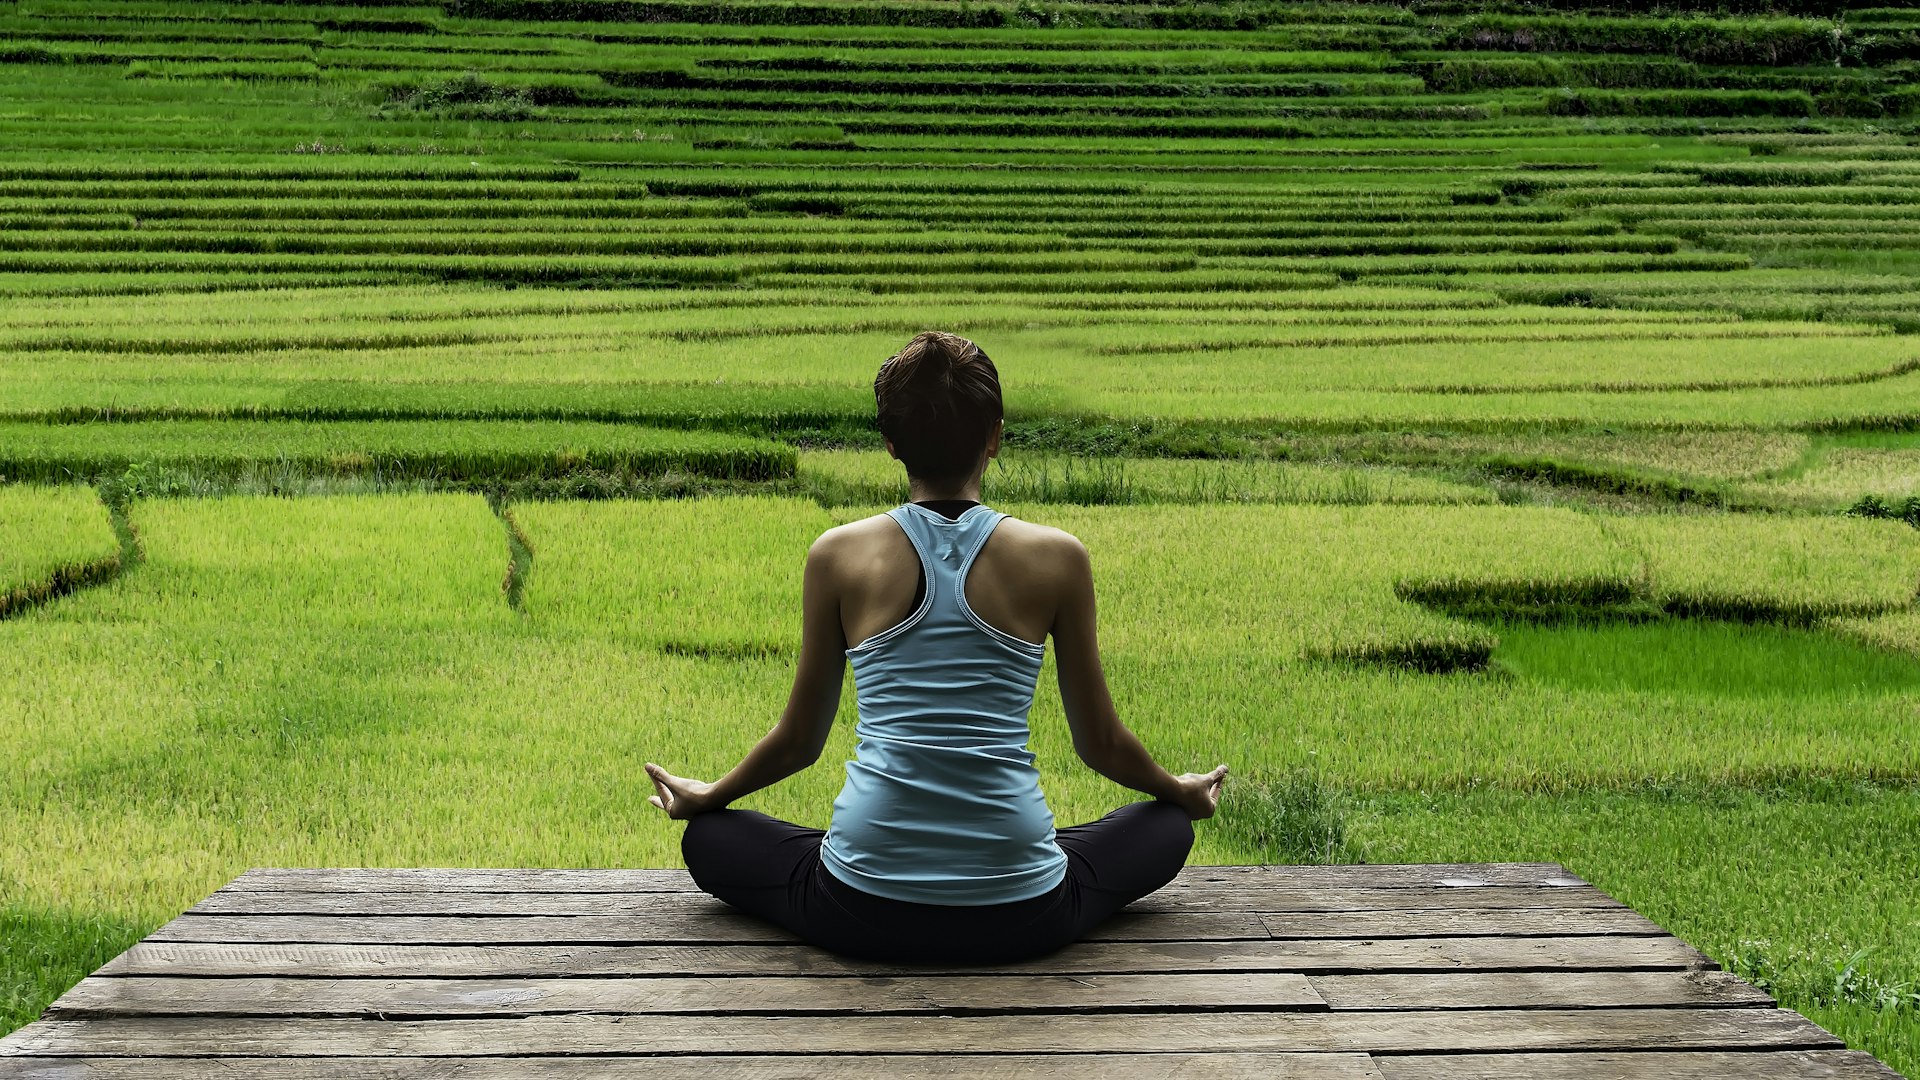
0;284;1920;430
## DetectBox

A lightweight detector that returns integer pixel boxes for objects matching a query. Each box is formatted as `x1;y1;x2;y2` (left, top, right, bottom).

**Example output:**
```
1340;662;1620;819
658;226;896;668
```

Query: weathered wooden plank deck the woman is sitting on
0;863;1895;1080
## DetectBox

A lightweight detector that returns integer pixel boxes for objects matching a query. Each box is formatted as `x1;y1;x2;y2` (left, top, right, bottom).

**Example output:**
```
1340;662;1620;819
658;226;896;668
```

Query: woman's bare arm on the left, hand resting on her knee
647;532;847;819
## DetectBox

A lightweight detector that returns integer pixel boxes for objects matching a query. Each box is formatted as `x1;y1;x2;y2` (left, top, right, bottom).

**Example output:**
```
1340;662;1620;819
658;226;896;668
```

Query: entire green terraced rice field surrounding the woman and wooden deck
0;0;1920;1072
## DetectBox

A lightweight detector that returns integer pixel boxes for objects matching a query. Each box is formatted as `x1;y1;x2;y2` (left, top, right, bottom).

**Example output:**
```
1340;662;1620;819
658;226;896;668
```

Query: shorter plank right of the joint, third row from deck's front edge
1308;970;1774;1009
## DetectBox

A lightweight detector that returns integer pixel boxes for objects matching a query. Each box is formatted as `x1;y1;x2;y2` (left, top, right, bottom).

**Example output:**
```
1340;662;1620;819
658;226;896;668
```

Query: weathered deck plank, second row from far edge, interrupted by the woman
192;886;1624;915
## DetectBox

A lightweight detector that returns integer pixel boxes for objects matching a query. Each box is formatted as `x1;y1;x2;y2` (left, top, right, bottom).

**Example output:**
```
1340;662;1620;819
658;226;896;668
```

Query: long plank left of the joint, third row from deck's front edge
46;972;1327;1019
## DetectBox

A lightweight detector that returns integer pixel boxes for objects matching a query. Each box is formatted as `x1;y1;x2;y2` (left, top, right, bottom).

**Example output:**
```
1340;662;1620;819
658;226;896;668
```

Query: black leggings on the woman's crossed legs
680;801;1194;965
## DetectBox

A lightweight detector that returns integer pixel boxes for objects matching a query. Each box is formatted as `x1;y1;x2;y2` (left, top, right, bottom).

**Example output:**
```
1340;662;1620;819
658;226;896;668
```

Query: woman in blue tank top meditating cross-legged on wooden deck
647;331;1227;963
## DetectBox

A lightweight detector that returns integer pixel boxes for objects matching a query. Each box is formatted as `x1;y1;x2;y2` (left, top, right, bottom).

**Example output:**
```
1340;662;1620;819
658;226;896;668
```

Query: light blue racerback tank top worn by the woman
820;503;1068;907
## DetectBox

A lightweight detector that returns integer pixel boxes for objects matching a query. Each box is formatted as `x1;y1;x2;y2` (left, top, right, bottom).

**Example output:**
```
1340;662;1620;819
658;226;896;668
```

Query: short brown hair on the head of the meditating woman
874;331;1002;480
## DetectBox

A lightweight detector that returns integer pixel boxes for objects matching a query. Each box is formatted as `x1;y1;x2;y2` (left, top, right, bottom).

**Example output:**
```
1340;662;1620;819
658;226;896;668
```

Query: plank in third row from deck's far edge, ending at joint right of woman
146;911;1267;945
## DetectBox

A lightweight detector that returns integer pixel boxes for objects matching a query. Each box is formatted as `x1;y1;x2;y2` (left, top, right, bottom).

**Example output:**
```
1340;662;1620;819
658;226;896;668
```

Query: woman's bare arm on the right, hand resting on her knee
1052;536;1227;819
